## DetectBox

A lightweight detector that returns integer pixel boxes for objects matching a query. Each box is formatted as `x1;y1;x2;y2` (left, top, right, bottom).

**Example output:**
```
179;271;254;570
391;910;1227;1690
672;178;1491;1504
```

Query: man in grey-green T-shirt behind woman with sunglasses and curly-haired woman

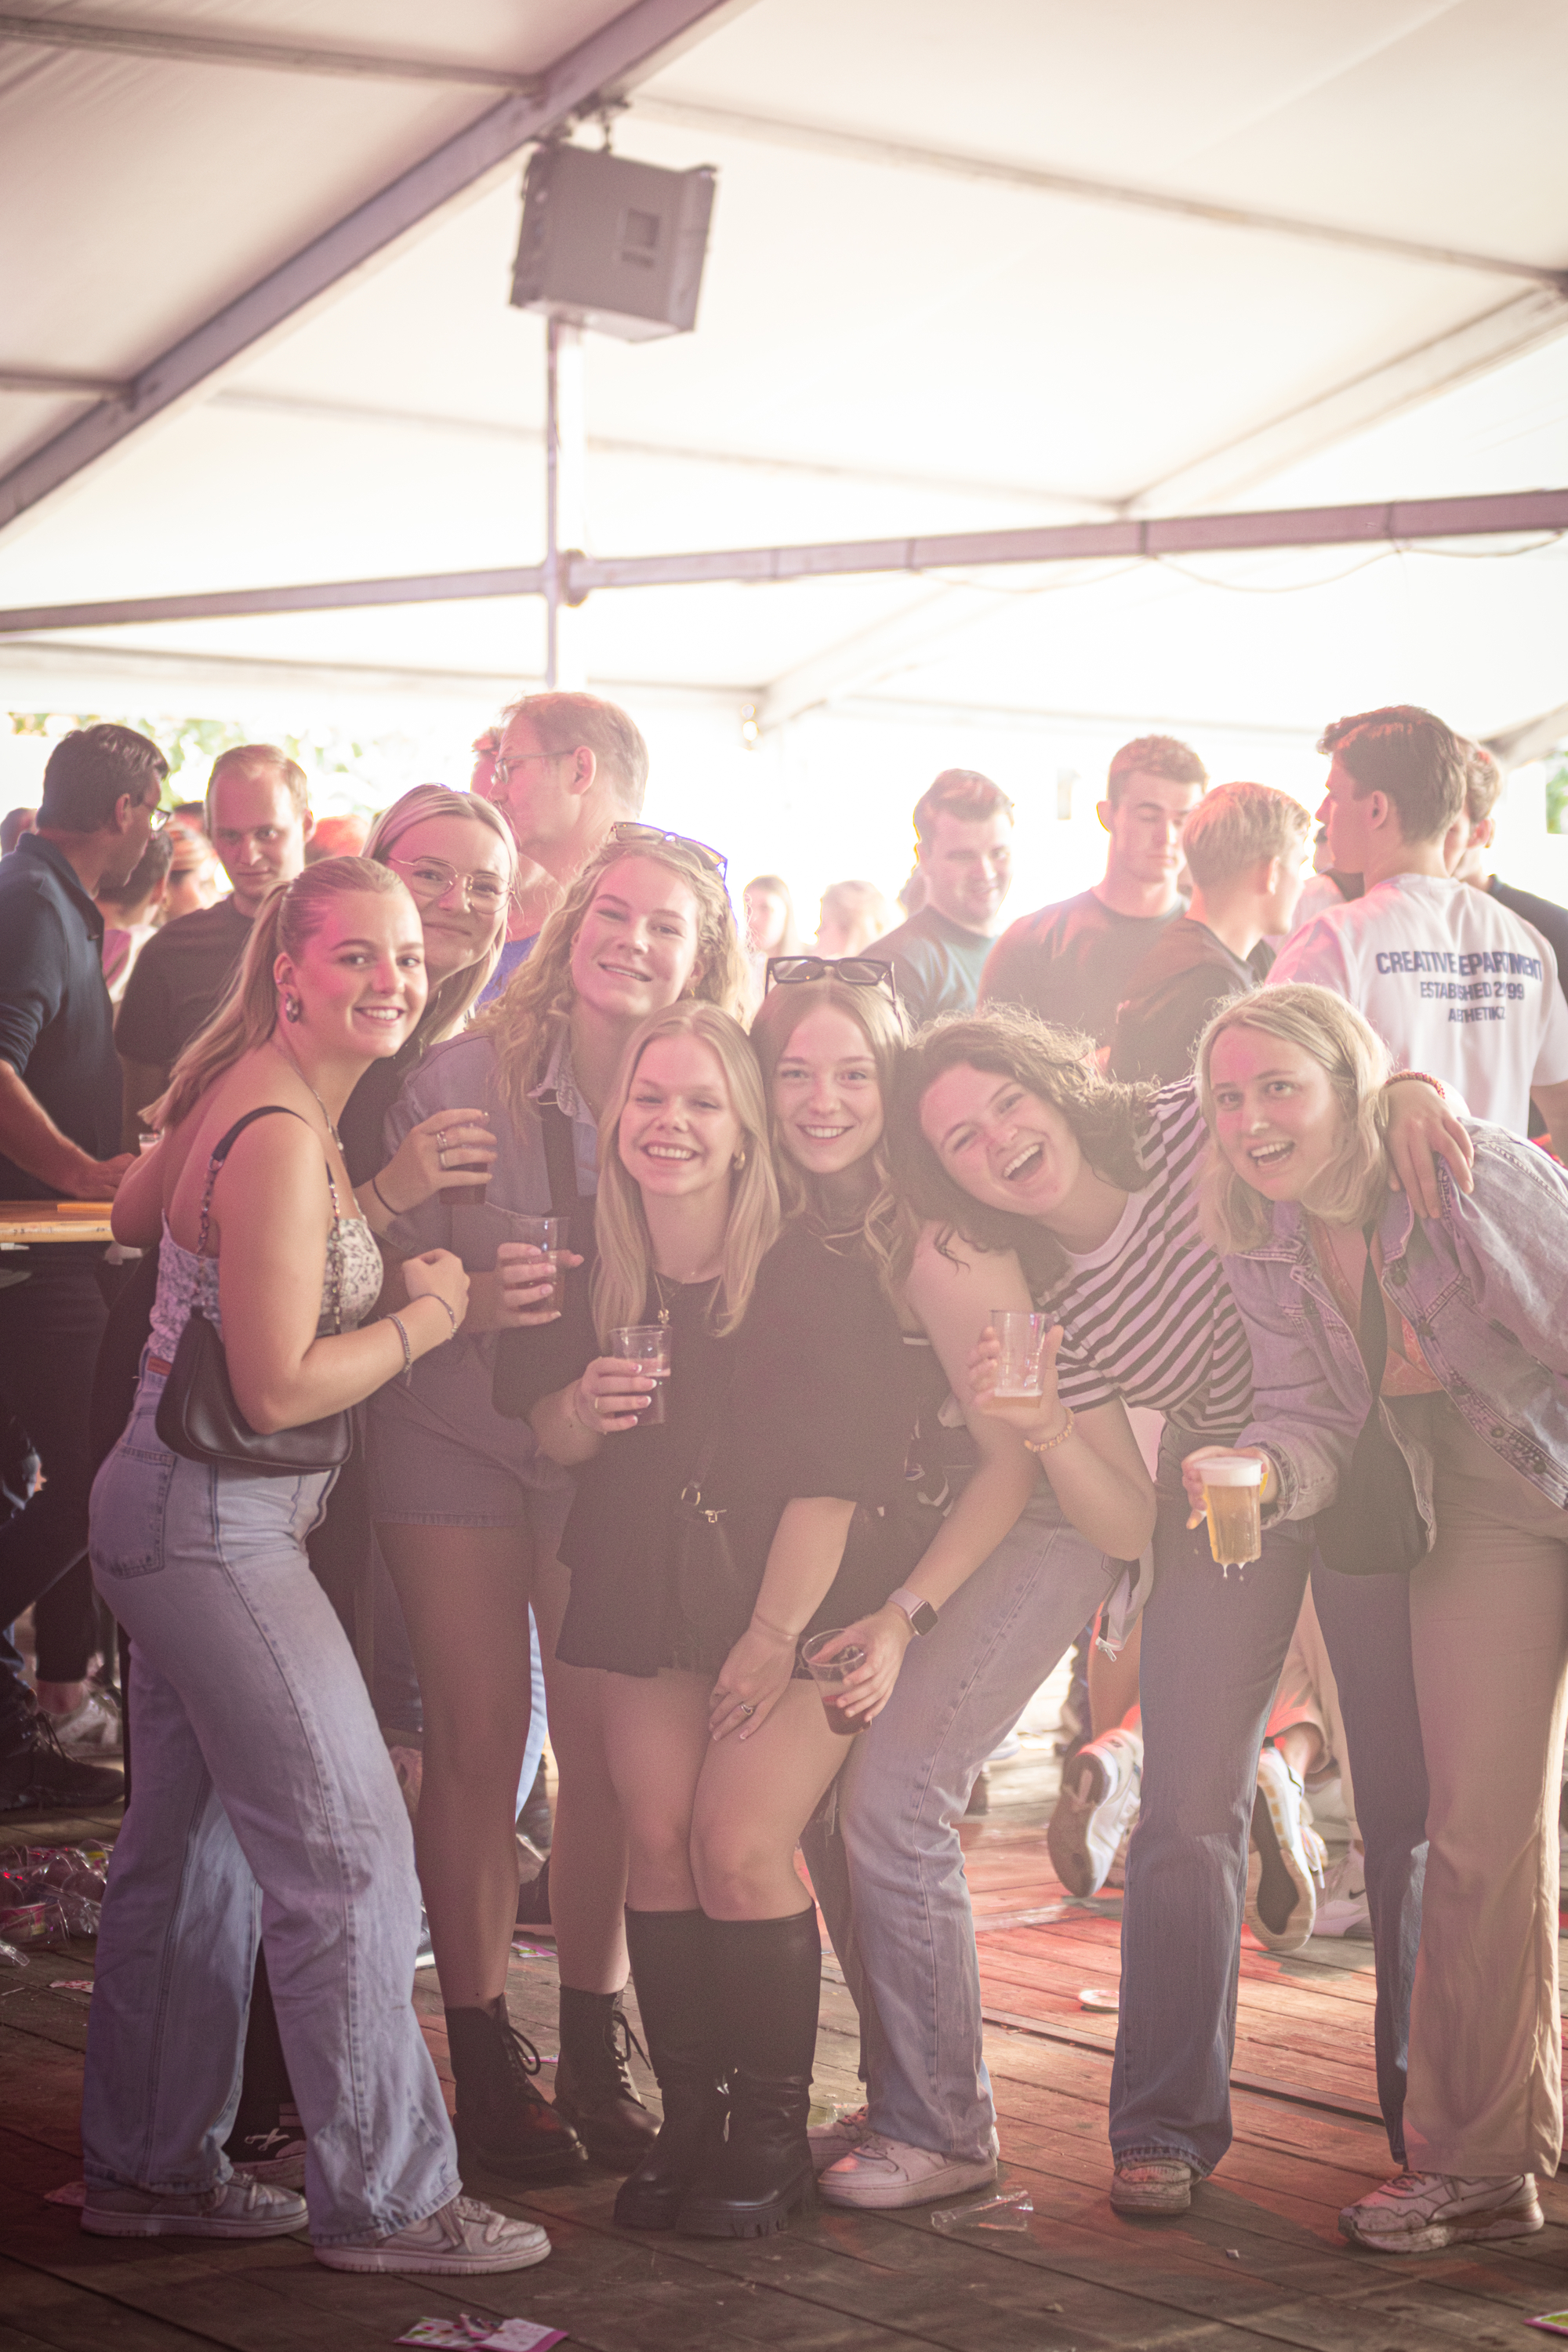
865;767;1013;1028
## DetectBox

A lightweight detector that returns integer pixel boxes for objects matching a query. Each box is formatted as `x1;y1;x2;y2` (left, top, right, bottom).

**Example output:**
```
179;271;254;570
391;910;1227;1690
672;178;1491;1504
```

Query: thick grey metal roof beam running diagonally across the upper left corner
0;0;750;532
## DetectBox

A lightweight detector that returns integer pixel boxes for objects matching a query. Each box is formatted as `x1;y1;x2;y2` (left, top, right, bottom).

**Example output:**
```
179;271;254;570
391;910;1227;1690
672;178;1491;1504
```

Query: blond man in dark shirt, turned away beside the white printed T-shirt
1107;783;1312;1087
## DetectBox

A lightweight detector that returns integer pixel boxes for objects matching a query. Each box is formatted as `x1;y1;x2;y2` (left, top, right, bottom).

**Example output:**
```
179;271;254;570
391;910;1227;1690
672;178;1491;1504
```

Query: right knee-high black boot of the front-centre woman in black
677;1910;822;2237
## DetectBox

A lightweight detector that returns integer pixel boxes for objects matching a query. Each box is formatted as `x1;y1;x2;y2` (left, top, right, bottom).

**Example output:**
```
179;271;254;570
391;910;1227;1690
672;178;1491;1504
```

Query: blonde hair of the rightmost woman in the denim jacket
1196;981;1389;1254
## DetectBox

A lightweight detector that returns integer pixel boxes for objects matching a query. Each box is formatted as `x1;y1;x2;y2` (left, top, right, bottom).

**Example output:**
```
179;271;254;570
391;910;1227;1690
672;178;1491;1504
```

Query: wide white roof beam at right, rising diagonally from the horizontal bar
1126;287;1568;515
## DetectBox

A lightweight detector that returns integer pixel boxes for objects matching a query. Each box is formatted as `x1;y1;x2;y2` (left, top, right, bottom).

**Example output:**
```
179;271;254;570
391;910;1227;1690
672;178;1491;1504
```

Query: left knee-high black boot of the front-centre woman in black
616;1910;724;2230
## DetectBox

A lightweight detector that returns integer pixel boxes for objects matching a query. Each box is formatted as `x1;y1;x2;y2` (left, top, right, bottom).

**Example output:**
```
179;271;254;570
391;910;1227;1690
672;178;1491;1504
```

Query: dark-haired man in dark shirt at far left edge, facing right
0;727;169;1813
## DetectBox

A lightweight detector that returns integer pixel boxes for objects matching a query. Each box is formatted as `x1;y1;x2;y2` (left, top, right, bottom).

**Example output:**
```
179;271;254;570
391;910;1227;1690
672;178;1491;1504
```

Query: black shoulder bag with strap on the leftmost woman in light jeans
155;1103;355;1477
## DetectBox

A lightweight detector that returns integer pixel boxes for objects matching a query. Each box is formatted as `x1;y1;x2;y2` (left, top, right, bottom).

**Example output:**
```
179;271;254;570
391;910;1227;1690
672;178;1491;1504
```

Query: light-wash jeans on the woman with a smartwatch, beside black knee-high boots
801;1477;1121;2161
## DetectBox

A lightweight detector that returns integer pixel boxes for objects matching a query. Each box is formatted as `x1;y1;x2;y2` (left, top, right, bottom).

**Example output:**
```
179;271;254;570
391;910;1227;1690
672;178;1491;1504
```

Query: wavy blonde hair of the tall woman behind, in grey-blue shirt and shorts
475;835;746;1117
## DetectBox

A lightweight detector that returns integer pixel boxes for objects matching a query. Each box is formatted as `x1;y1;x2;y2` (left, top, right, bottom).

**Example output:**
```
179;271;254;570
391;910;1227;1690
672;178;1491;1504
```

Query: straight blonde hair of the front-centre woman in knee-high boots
593;997;779;1348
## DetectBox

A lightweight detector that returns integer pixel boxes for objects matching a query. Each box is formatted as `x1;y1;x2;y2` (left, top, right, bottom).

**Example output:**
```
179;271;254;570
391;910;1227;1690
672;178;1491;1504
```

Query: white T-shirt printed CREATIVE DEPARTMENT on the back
1269;875;1568;1136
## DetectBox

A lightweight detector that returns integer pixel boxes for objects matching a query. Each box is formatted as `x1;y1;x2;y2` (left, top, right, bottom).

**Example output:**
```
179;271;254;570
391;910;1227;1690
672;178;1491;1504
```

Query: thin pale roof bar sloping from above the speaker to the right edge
637;96;1568;289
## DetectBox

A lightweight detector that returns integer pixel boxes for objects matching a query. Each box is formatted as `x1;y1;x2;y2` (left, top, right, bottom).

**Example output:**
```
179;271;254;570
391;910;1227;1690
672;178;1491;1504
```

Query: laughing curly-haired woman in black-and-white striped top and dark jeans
895;1009;1469;2213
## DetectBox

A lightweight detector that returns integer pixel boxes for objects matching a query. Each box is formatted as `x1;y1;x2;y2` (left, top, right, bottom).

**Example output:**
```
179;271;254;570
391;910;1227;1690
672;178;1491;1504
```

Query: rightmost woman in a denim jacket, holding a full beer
1182;985;1568;2253
